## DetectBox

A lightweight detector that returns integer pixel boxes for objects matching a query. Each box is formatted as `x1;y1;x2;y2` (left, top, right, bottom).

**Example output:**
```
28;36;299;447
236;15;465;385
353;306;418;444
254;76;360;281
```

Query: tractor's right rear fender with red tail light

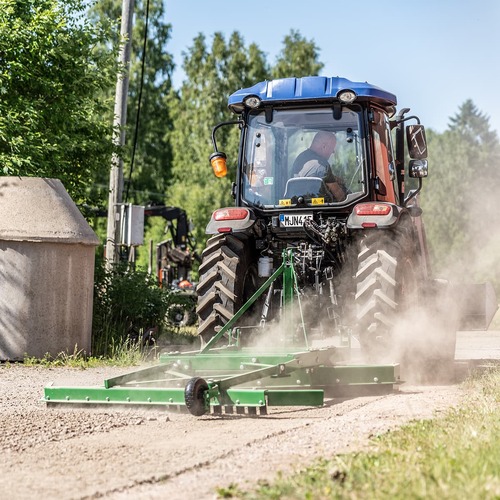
347;201;408;229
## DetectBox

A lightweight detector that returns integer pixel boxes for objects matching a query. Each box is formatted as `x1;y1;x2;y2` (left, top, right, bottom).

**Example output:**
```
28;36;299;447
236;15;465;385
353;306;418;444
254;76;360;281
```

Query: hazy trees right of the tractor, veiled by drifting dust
421;100;500;285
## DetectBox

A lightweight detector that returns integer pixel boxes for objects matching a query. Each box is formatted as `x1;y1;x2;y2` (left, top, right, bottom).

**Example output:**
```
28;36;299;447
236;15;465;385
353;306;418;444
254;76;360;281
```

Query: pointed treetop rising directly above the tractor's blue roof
272;30;324;78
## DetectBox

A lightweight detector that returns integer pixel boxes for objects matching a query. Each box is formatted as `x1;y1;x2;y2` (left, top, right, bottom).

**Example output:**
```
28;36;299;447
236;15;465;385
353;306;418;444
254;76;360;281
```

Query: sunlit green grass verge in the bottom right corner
218;367;500;500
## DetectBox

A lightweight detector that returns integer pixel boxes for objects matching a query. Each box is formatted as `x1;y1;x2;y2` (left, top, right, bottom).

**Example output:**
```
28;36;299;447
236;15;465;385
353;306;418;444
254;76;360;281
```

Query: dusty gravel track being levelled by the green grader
0;335;500;500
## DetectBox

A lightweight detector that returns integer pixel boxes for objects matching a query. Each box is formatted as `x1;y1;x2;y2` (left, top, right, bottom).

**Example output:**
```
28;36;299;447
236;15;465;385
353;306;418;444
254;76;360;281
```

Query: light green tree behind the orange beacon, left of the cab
166;32;268;244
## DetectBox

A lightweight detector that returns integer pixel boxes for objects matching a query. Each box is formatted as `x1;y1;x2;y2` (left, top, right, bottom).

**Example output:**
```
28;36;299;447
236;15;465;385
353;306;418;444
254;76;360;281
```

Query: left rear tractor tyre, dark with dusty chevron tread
196;234;258;344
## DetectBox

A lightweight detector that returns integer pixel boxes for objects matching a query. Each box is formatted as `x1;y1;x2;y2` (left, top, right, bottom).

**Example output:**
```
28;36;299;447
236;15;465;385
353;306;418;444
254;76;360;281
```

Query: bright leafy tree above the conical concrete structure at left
0;0;116;203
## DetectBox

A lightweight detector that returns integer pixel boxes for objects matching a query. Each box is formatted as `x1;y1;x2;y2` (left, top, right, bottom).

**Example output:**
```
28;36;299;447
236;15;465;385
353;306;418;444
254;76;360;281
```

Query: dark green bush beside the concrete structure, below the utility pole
92;256;170;356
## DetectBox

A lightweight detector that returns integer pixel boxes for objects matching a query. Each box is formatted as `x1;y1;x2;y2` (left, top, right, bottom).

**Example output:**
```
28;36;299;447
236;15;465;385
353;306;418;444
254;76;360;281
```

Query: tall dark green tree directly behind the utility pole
92;0;174;204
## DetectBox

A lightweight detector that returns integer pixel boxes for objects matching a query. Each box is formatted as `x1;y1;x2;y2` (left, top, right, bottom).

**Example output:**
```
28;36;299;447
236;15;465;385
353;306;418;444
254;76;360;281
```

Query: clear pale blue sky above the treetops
165;0;500;134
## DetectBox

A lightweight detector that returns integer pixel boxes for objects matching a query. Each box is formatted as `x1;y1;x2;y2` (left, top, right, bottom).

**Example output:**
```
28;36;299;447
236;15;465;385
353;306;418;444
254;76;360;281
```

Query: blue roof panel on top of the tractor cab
228;76;397;113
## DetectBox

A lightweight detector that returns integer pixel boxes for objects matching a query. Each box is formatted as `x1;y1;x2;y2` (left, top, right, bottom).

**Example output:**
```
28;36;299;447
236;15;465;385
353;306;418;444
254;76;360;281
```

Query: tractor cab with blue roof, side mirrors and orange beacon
211;77;427;218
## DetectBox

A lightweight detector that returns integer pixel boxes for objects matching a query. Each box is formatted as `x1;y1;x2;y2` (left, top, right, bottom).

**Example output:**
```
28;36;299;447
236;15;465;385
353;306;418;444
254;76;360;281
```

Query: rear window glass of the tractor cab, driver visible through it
241;107;365;208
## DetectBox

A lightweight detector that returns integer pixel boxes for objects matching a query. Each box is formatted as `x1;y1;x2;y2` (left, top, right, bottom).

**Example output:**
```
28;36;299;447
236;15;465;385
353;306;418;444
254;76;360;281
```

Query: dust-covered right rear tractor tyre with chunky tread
355;230;419;362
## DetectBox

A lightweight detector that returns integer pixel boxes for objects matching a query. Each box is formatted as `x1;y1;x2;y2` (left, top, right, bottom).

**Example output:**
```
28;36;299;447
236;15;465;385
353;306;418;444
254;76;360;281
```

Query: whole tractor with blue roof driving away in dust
197;76;496;370
